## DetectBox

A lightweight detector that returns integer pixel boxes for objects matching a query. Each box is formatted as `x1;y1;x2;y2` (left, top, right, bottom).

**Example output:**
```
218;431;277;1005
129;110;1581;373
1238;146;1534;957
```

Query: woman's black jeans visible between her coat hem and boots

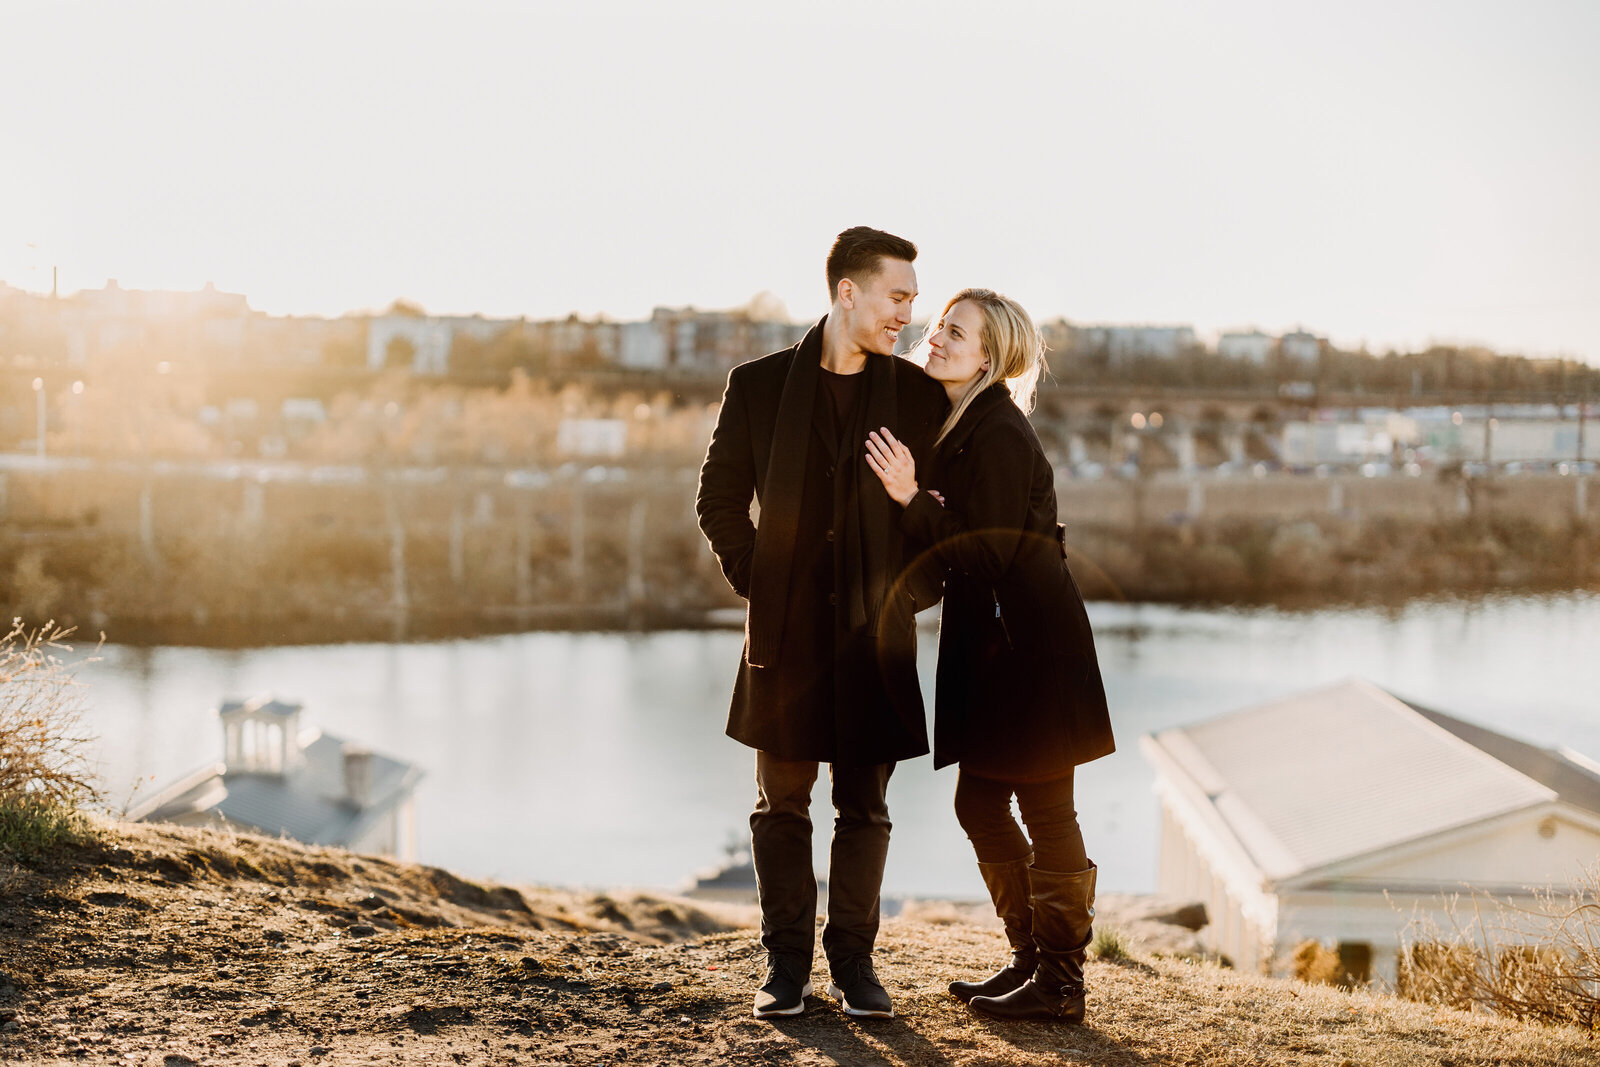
955;768;1090;873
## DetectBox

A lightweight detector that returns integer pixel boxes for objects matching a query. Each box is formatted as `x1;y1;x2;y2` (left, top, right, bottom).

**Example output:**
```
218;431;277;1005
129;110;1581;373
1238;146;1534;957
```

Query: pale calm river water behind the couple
68;593;1600;897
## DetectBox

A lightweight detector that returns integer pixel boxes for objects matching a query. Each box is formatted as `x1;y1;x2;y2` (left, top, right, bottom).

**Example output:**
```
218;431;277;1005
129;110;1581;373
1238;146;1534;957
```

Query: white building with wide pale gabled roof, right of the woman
1139;680;1600;982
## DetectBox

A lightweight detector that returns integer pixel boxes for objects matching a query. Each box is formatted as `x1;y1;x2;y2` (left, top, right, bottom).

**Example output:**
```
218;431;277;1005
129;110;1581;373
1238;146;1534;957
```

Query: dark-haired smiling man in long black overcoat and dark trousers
696;226;947;1017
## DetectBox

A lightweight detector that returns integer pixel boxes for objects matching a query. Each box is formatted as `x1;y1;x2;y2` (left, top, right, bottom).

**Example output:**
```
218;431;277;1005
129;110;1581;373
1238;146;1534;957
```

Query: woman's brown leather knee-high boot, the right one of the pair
971;864;1098;1022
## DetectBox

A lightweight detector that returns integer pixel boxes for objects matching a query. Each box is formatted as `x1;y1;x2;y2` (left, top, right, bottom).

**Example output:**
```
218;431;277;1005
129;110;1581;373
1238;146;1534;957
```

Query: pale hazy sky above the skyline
9;0;1600;363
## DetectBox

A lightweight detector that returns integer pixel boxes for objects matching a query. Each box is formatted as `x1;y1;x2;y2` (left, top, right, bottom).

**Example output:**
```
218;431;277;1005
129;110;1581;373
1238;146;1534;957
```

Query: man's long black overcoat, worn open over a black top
694;318;947;765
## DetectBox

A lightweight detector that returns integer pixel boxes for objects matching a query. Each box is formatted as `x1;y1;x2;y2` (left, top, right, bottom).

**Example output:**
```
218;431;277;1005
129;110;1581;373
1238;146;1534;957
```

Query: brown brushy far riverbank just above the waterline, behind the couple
9;457;1600;648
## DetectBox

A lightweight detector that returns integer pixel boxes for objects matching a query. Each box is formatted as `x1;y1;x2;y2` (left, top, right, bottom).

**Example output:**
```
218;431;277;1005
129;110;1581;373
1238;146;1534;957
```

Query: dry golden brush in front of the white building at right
1395;864;1600;1032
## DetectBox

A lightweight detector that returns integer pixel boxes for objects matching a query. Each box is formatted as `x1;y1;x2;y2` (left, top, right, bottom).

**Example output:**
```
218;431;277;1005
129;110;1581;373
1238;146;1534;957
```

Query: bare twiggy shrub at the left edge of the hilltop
0;619;99;851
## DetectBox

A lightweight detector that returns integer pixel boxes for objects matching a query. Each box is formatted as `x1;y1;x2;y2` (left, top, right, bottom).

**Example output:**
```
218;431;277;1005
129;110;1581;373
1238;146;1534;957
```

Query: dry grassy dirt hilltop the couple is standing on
0;824;1600;1067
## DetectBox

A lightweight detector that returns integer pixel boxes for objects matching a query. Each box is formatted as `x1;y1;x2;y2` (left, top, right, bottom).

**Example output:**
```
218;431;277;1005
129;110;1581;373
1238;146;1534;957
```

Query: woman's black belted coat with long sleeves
901;384;1115;782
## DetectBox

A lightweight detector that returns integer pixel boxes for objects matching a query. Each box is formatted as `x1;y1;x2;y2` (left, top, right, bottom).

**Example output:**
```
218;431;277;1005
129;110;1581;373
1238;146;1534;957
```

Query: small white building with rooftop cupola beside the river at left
128;699;422;861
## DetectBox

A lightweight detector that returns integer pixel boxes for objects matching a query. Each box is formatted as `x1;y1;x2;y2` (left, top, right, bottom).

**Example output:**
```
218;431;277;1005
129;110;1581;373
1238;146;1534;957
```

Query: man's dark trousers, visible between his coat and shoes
750;752;894;966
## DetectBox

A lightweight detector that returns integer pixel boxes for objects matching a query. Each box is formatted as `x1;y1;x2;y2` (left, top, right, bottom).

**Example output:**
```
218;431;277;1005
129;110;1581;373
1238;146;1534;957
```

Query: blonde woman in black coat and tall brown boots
867;290;1115;1022
